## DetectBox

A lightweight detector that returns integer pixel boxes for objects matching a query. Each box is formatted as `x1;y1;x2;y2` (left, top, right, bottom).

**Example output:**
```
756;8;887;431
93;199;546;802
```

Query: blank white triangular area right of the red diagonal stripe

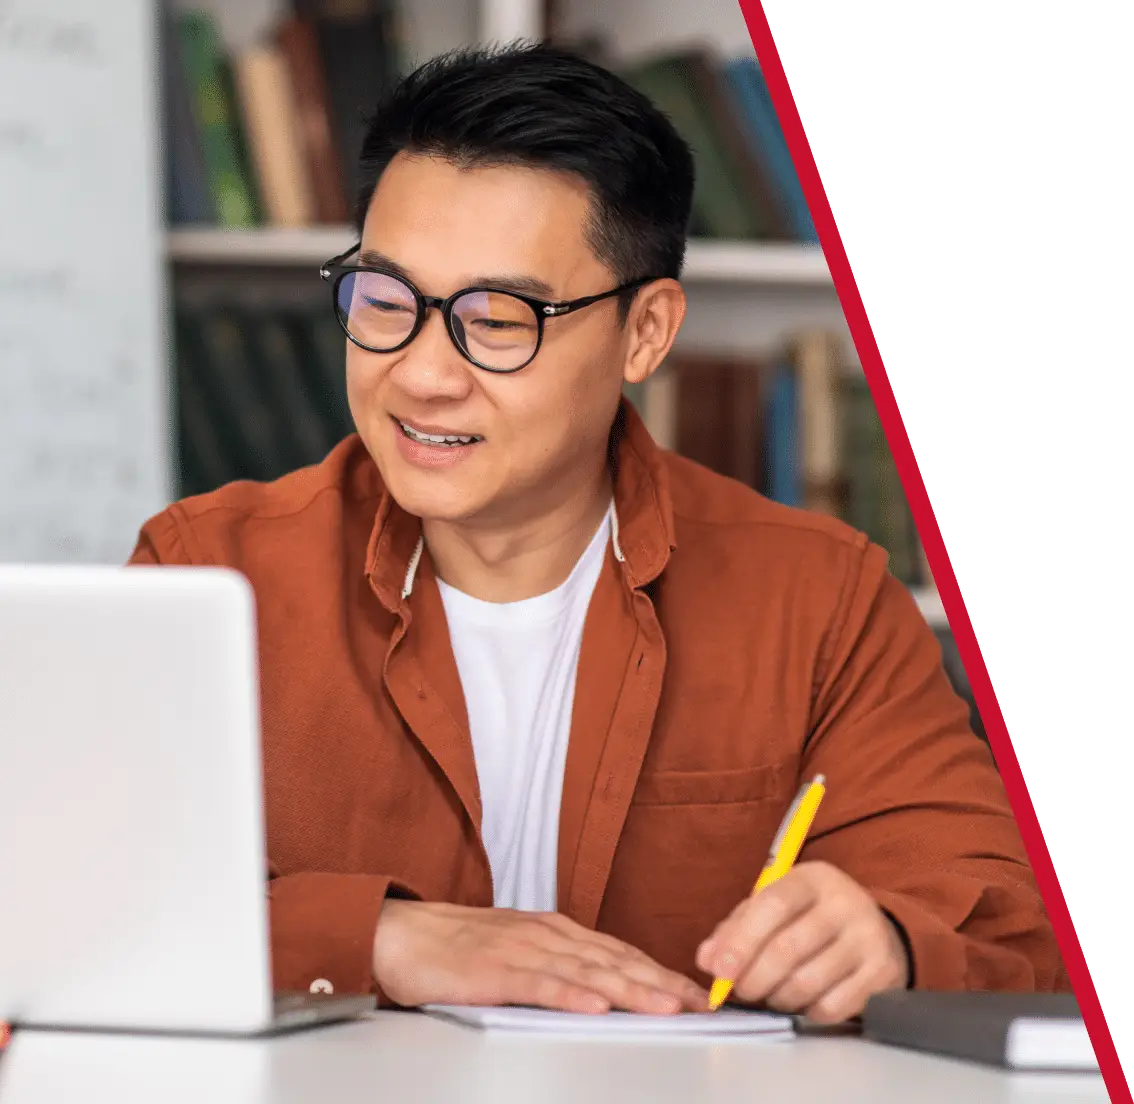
752;0;1134;1076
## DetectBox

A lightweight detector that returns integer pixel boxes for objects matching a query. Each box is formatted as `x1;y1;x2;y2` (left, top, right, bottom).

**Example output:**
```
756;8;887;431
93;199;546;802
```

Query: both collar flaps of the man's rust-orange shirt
366;399;676;613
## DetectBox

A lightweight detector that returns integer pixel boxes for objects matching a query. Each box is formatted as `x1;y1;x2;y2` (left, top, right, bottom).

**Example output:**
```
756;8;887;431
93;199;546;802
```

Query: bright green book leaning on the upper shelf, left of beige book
178;11;256;228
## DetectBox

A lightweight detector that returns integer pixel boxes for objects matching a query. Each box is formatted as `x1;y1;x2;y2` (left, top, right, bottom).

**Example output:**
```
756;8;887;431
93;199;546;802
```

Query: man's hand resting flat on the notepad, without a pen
374;900;708;1016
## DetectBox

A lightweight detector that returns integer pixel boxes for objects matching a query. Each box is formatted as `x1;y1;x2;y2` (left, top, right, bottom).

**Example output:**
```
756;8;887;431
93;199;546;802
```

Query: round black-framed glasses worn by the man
319;243;655;373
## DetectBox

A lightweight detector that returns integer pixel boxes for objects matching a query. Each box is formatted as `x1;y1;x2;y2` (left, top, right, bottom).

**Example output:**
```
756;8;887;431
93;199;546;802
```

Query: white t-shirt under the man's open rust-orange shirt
440;510;611;912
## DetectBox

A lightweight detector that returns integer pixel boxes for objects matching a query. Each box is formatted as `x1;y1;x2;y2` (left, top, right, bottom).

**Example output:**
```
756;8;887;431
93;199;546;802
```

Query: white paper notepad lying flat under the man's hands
424;1004;794;1038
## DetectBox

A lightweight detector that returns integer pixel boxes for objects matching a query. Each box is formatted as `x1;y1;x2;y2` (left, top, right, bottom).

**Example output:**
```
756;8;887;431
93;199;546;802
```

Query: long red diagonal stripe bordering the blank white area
739;0;1134;1102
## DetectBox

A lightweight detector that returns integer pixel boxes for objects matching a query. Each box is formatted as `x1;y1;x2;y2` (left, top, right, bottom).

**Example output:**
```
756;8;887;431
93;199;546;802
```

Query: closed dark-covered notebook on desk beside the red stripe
862;992;1099;1072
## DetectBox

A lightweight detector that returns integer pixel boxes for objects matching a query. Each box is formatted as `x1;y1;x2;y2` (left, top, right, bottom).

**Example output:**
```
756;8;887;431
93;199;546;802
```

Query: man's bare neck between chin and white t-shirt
422;470;611;602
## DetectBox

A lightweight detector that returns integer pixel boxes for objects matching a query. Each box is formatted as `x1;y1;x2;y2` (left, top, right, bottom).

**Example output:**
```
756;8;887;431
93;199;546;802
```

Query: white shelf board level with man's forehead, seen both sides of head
167;227;831;288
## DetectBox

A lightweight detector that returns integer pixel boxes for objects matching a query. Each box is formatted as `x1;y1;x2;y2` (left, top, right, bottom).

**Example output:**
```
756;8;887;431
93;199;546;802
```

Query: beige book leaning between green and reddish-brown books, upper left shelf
232;43;315;227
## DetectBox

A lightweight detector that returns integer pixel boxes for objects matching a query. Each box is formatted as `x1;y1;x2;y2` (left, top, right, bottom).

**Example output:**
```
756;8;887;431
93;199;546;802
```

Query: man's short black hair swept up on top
355;43;693;319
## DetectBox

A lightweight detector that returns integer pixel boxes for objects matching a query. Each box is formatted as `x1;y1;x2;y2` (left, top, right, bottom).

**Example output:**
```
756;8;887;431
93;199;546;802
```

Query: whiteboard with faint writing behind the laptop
0;0;171;563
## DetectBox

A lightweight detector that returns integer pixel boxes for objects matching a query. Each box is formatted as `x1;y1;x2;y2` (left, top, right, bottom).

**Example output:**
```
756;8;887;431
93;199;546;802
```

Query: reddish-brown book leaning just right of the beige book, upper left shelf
276;17;353;226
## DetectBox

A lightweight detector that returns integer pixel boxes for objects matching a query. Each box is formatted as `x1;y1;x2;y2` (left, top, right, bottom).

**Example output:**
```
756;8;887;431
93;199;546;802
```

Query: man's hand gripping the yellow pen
697;863;909;1024
